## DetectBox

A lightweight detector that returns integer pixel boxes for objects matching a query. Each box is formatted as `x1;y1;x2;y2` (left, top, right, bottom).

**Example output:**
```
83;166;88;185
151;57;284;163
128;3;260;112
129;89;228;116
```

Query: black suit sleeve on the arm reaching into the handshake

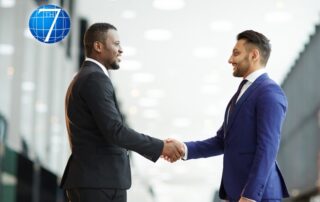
80;73;163;161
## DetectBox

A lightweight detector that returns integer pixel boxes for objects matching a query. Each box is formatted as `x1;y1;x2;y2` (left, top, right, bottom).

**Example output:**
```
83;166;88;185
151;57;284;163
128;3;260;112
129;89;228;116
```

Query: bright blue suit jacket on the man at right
186;74;289;201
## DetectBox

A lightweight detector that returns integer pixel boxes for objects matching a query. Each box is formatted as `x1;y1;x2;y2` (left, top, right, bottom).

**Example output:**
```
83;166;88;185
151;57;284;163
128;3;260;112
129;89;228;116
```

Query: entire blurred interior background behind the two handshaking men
0;0;320;202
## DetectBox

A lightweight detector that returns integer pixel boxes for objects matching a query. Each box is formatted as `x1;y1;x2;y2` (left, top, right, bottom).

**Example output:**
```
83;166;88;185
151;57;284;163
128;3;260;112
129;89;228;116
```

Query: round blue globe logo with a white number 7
29;4;70;44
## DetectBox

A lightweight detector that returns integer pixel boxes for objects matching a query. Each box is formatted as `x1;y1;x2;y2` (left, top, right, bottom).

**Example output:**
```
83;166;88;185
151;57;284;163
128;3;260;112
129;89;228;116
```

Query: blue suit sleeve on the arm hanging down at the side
243;90;287;201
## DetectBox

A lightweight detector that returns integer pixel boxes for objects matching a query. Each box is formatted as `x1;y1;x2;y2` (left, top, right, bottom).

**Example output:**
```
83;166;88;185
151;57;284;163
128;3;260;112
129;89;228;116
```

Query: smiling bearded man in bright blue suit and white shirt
180;30;289;202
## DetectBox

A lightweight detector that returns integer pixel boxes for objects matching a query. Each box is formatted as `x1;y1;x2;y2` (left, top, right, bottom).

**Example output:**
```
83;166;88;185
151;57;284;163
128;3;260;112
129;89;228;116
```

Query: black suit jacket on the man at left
61;61;163;189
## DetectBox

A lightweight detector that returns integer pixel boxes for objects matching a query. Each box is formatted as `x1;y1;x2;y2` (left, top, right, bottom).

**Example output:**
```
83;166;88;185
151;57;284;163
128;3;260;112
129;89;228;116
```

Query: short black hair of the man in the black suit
83;23;117;56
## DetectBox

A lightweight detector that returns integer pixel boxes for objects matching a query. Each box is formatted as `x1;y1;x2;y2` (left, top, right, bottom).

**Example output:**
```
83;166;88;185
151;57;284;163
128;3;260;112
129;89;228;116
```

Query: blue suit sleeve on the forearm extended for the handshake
185;125;224;160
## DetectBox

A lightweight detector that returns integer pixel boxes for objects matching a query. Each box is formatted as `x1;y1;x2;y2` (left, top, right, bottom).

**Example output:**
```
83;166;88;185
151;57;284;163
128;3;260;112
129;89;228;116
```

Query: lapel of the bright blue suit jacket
225;73;269;133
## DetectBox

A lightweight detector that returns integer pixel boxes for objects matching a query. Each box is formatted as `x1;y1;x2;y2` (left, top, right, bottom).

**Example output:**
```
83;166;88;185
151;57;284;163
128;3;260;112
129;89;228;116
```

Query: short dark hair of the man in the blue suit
237;30;271;65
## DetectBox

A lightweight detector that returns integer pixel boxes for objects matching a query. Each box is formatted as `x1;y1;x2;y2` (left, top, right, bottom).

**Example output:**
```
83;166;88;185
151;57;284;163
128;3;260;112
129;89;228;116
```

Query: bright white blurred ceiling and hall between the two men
77;0;320;202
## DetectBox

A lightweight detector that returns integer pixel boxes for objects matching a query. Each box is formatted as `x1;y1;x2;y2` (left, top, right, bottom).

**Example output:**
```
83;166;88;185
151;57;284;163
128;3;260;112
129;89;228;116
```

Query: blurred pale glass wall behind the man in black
0;0;78;175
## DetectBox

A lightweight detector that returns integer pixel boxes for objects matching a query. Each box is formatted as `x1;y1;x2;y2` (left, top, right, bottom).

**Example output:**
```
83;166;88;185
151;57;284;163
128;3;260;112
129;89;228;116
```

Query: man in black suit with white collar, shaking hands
61;23;183;202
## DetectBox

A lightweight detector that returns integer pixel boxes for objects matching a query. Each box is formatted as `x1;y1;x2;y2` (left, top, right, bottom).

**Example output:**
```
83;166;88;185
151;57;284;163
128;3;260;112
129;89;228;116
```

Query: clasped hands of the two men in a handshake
161;138;185;163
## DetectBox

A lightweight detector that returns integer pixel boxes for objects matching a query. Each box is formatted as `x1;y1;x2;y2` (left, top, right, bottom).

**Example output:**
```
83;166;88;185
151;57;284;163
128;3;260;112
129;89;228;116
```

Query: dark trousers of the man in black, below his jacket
66;188;127;202
